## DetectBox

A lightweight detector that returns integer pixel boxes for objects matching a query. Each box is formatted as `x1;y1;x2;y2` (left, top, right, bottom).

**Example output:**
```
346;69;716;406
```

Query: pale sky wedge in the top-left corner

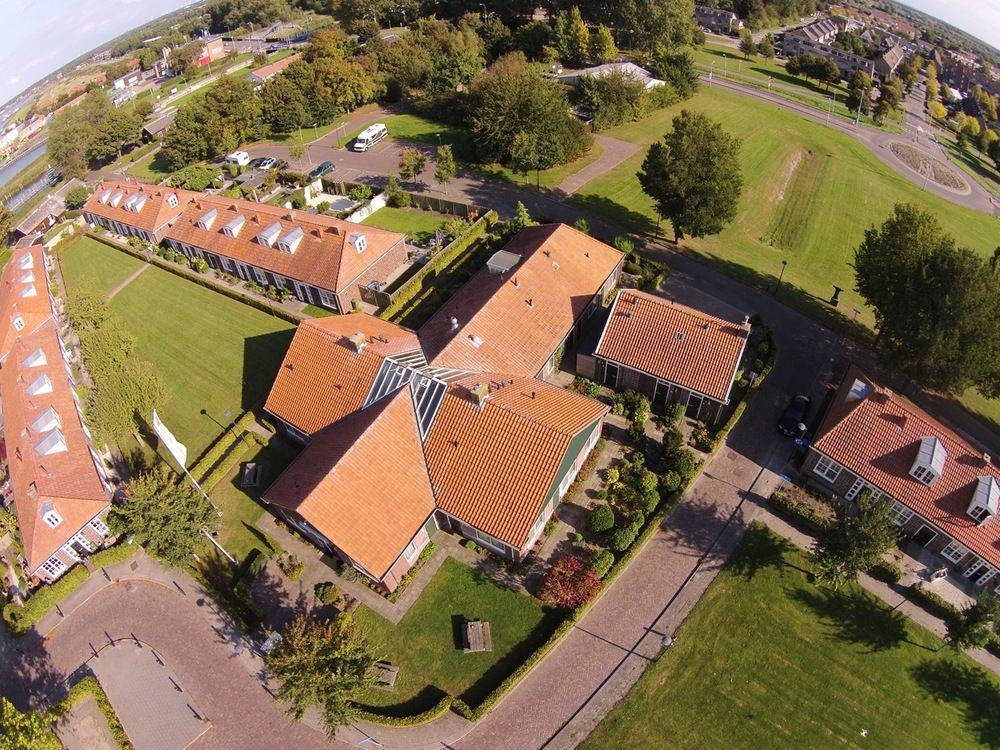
0;0;191;103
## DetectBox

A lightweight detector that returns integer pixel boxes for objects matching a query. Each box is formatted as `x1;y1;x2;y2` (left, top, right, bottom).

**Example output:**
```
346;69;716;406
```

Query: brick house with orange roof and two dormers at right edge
803;368;1000;586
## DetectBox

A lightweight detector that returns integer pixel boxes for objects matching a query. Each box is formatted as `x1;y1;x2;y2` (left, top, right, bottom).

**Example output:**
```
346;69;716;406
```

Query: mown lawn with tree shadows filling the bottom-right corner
583;526;1000;749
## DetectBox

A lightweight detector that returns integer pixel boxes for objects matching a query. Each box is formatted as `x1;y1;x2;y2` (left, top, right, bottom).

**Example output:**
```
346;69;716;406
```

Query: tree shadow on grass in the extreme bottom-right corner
910;659;1000;750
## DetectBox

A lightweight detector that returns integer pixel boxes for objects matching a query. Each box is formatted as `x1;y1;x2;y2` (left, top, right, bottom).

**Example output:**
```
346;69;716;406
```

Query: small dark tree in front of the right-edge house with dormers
813;491;899;588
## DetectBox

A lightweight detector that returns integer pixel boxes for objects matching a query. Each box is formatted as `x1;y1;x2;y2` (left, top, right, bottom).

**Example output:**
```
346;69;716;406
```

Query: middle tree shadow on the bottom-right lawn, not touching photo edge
792;588;916;653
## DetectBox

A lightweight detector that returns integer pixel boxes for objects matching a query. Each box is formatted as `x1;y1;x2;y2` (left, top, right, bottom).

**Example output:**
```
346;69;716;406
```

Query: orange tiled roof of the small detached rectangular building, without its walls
595;289;749;401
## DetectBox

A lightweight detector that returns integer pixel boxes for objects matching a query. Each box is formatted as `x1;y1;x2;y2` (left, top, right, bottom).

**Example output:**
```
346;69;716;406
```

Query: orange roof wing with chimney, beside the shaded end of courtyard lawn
264;313;420;435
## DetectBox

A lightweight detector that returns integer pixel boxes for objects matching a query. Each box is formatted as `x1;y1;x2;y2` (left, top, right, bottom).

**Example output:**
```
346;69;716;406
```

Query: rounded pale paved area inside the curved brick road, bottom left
89;640;211;750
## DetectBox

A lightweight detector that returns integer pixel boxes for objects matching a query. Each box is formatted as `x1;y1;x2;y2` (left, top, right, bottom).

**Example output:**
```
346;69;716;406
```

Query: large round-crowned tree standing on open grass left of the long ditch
639;109;743;240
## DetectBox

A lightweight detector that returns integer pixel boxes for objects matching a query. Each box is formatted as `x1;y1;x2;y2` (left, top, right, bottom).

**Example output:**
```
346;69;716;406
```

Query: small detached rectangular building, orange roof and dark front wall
586;289;750;423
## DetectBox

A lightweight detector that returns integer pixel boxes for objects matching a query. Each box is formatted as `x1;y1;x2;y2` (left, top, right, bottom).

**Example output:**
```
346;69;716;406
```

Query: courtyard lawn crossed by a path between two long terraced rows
61;240;293;463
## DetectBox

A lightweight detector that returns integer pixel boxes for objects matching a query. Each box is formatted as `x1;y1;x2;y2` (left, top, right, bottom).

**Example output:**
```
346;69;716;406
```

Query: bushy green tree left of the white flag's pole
108;470;219;566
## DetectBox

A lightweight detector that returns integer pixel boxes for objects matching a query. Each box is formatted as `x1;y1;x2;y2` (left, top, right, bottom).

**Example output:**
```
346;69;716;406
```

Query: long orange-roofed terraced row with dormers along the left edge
0;246;111;581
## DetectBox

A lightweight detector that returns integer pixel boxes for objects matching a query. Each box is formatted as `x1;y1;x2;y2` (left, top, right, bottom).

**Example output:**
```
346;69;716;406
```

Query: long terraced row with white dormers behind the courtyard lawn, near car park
84;180;407;312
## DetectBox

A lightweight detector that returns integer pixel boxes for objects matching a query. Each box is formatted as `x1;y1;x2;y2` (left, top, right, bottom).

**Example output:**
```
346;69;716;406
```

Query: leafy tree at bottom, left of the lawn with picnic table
265;614;376;740
